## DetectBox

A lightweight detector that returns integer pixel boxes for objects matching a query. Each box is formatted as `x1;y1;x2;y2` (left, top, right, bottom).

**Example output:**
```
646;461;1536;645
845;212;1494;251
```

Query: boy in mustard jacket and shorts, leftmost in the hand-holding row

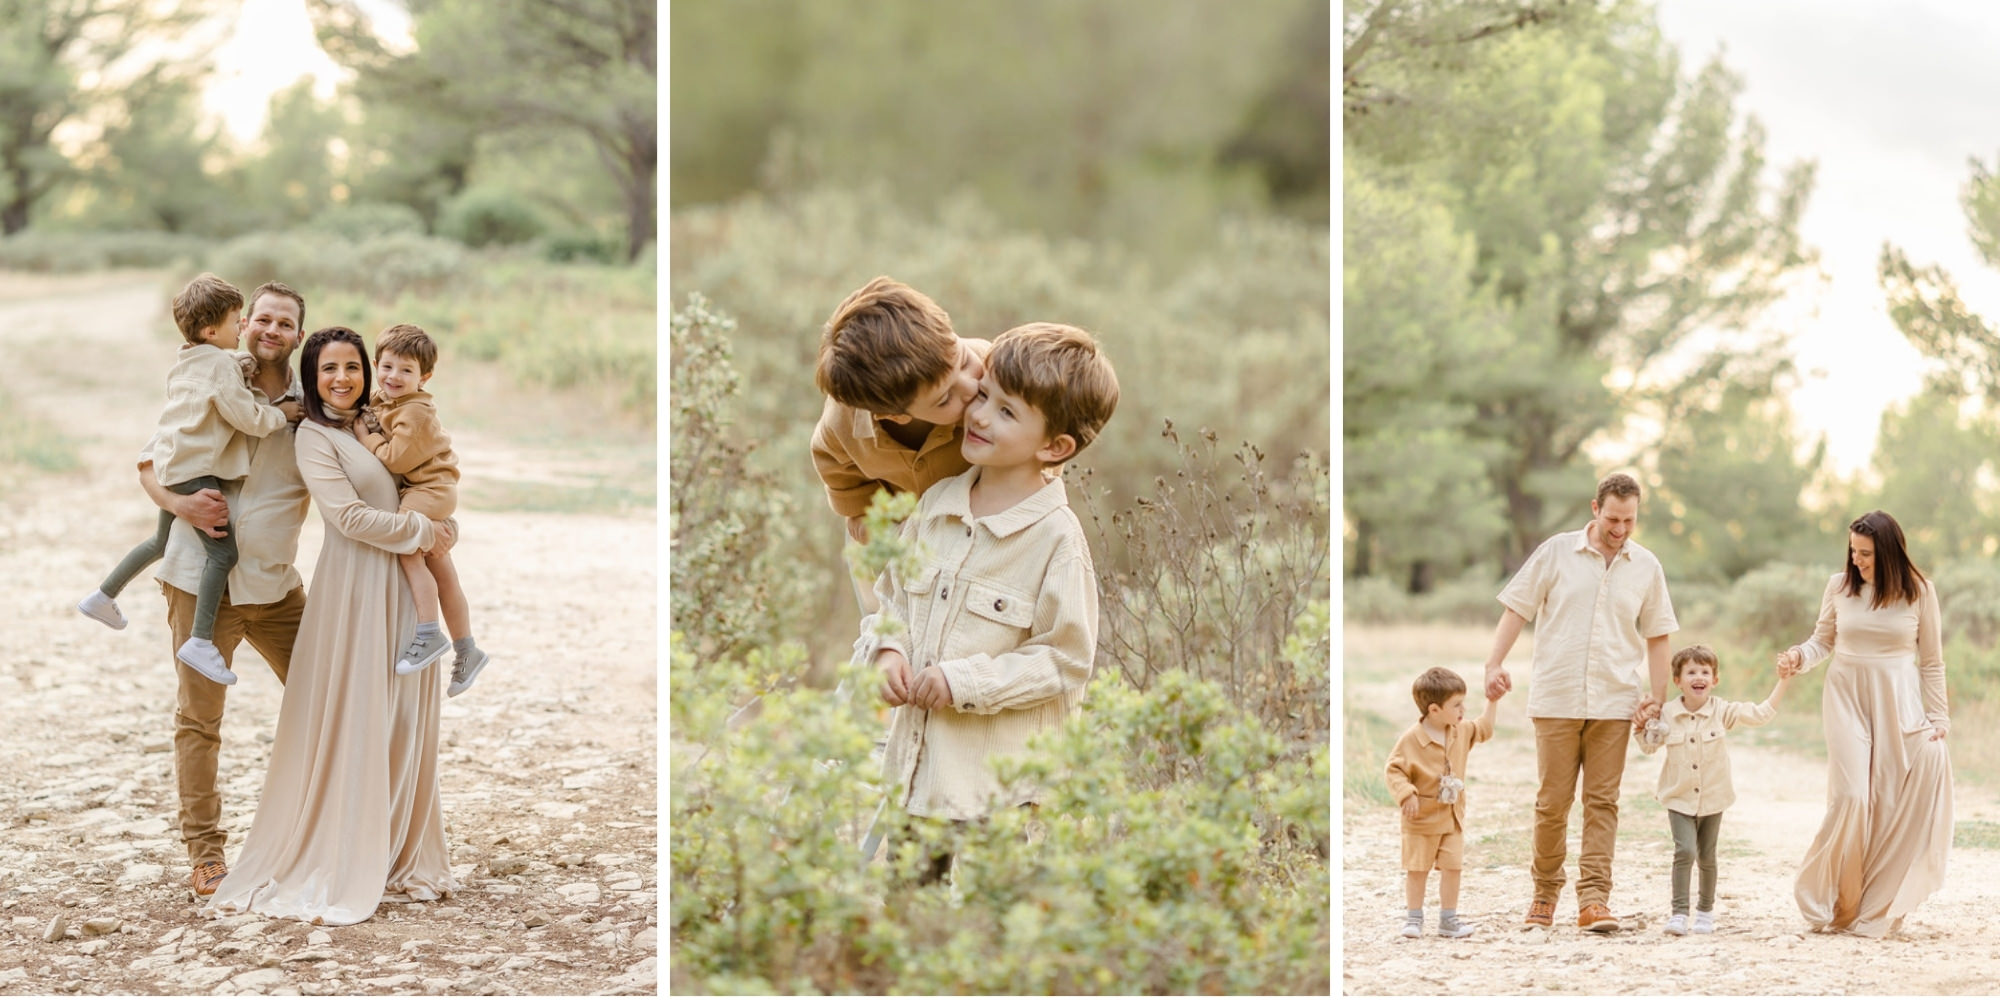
1388;666;1500;938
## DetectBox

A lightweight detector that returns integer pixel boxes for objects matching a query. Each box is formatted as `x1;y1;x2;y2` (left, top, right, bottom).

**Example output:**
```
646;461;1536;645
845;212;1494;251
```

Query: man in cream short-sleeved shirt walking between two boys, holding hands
1486;474;1680;932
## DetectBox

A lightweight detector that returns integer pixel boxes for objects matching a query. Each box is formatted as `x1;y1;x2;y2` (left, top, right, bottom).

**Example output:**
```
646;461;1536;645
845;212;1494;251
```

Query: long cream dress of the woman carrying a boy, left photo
202;420;458;924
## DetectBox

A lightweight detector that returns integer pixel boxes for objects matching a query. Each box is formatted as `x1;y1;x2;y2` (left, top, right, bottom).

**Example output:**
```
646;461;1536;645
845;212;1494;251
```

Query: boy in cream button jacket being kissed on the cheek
858;322;1118;880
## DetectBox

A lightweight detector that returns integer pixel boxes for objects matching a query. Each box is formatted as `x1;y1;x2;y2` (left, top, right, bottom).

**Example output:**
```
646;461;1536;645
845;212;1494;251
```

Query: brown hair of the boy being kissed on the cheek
986;322;1118;458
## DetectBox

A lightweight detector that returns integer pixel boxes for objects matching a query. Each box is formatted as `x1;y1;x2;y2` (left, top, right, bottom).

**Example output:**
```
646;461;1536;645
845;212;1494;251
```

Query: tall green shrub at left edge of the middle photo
668;296;816;658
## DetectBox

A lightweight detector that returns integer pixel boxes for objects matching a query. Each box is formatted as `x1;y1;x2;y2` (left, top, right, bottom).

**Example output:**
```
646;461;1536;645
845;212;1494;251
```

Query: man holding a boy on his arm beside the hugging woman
138;282;312;896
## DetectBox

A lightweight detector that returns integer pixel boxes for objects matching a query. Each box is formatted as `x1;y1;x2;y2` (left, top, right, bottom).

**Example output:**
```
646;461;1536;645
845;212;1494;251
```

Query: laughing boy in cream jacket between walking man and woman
1634;644;1790;934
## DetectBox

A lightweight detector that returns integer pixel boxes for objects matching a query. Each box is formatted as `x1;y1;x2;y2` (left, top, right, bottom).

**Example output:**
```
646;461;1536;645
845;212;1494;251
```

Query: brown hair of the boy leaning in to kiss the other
812;276;960;416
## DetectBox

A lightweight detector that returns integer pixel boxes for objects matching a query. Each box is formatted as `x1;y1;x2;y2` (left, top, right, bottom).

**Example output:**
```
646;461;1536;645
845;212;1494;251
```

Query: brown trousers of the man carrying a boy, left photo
160;584;306;864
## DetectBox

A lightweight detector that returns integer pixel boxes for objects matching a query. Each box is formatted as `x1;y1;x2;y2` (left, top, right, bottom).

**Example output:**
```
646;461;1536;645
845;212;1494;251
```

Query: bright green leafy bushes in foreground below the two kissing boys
670;636;1330;994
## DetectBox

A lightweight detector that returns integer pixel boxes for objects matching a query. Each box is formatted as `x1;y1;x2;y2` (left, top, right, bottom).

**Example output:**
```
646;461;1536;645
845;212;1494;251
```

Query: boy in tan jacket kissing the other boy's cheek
812;276;992;612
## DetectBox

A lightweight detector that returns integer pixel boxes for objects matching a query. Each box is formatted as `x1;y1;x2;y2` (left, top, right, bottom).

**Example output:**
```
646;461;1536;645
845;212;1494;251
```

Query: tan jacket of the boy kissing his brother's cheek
796;338;992;518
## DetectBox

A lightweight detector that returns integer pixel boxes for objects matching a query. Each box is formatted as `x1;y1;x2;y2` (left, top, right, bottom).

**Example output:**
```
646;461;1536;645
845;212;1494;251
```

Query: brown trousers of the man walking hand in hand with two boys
1534;718;1632;908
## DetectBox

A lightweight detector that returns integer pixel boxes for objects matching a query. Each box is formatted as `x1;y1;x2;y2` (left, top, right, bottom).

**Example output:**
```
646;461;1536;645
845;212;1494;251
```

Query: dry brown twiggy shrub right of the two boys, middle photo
1076;420;1328;740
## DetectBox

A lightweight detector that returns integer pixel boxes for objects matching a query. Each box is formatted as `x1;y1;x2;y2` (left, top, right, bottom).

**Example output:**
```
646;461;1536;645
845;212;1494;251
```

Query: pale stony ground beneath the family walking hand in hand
1342;626;2000;996
